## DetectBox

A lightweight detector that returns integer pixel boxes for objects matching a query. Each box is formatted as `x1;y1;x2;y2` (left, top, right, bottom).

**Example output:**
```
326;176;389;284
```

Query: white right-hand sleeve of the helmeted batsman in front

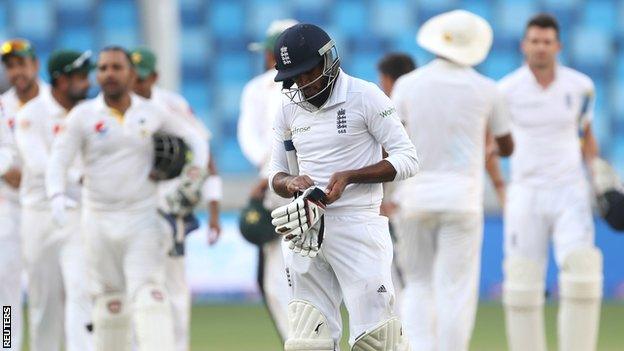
363;87;419;180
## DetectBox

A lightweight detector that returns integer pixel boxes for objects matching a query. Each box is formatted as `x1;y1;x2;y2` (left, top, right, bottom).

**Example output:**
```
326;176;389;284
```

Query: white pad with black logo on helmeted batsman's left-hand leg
284;300;334;351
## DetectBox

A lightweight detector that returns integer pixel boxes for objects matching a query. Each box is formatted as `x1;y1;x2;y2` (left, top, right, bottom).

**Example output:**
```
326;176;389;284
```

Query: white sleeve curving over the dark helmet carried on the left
155;104;209;169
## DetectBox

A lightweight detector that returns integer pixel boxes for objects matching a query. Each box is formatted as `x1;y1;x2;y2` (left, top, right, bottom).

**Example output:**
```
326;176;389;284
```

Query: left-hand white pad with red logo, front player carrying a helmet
93;294;132;351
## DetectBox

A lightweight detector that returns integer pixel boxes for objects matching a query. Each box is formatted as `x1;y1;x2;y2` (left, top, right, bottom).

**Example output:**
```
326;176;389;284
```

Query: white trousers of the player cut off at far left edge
0;201;22;351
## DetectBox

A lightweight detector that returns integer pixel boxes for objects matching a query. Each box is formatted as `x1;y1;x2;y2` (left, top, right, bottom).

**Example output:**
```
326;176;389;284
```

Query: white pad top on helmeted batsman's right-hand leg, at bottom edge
351;317;410;351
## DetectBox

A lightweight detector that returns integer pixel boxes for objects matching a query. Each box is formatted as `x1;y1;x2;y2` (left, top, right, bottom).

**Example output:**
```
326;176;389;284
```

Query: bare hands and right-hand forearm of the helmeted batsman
273;160;396;204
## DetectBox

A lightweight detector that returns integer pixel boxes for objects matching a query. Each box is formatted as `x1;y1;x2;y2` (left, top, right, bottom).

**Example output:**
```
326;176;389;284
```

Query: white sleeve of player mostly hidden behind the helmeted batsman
237;81;269;168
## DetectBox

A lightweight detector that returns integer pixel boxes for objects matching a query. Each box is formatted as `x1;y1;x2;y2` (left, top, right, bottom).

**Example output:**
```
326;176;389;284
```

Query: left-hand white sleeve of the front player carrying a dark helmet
46;108;84;197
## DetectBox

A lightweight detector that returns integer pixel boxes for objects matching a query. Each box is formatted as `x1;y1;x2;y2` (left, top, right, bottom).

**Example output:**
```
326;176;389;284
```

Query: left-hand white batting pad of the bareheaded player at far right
503;257;546;351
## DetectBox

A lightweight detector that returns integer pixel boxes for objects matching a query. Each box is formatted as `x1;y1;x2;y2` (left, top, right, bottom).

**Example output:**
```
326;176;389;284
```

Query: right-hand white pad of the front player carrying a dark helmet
134;284;175;351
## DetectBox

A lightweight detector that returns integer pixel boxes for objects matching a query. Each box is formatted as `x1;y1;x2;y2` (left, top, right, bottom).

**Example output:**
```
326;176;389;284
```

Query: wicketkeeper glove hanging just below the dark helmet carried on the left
167;165;207;217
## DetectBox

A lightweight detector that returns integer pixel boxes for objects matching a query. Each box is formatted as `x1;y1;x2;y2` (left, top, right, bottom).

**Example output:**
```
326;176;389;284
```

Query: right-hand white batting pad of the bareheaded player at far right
558;247;602;351
